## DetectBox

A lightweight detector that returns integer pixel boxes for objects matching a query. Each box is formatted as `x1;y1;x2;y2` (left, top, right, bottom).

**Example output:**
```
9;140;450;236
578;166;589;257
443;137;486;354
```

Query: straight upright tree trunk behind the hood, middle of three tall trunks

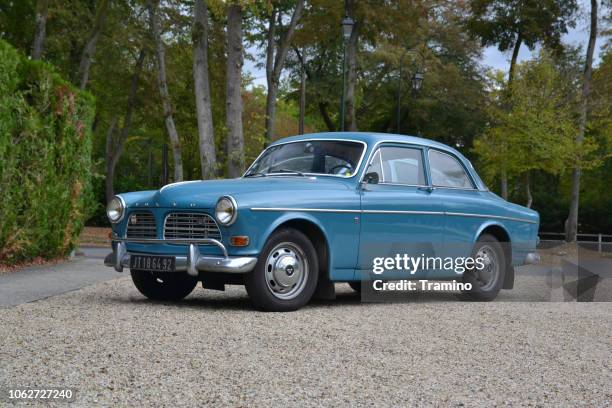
192;0;217;180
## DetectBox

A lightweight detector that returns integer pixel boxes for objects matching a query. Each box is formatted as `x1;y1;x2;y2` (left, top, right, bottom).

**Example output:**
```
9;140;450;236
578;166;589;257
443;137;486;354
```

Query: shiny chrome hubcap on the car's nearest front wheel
266;242;308;300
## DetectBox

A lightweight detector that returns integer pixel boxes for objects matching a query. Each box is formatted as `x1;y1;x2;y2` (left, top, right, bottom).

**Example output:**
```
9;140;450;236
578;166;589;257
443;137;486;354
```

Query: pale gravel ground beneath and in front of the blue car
0;277;612;407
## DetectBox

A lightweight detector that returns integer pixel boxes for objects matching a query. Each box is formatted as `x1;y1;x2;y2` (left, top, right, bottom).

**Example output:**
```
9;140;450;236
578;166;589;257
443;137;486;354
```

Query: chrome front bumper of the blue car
104;237;257;276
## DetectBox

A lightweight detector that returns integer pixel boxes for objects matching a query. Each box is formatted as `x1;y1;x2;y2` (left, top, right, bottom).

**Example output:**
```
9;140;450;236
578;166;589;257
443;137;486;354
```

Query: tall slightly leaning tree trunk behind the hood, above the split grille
148;1;183;182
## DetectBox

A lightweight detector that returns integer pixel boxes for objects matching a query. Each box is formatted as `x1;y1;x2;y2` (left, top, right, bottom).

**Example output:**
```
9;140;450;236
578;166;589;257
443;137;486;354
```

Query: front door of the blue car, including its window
357;144;444;278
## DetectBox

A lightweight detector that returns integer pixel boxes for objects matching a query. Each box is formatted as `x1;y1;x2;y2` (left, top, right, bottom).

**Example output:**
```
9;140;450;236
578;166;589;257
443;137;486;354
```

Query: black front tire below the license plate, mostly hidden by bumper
130;269;198;301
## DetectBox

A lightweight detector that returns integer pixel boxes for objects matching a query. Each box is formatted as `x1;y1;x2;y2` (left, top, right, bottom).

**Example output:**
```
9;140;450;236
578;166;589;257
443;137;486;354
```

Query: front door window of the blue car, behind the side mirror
368;146;425;186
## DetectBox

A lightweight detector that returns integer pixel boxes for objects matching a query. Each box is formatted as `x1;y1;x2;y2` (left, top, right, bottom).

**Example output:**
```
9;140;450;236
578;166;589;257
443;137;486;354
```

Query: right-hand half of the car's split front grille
164;213;221;240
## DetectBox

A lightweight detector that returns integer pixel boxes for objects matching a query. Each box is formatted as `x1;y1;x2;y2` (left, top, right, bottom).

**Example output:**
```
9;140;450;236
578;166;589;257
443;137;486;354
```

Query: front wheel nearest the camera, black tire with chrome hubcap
245;228;319;312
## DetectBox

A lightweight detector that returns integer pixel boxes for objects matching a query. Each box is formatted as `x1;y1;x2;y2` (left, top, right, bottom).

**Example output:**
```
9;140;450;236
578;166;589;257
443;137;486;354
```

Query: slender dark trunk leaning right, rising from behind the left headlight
106;49;145;202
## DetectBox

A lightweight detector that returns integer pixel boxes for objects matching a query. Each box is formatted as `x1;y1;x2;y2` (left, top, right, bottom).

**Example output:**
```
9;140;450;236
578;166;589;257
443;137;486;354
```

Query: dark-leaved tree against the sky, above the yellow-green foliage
466;0;577;199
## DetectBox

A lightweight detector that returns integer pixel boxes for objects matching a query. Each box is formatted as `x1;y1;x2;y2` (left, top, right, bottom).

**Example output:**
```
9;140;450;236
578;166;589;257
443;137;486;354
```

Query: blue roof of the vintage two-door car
271;132;465;160
